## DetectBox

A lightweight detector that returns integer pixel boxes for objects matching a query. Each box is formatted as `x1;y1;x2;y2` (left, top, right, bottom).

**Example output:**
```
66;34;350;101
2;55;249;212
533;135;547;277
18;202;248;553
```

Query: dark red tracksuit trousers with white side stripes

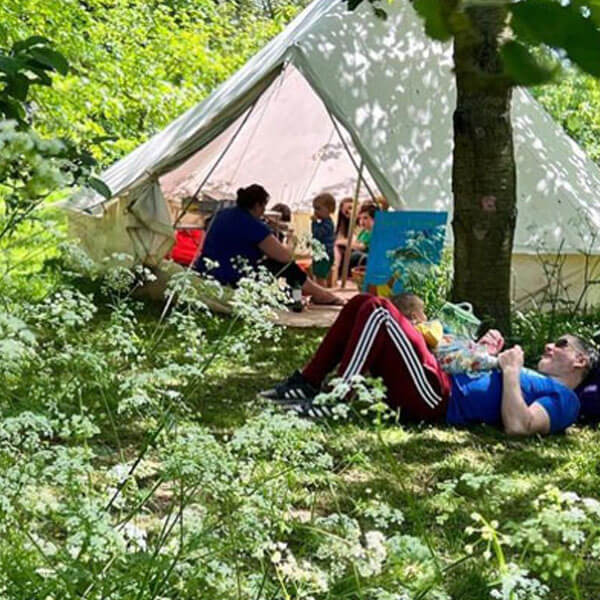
302;294;450;421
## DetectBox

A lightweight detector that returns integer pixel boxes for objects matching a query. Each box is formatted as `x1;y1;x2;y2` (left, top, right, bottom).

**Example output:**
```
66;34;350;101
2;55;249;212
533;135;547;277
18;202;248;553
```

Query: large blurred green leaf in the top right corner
510;0;600;77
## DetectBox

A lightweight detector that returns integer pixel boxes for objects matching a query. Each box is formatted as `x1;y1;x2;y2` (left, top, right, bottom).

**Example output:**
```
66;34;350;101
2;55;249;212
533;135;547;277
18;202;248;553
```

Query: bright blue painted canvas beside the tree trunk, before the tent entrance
363;211;448;297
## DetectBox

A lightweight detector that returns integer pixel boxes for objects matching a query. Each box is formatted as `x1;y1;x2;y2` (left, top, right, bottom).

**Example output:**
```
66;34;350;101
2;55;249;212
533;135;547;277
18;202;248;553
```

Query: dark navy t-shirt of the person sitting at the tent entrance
194;206;271;284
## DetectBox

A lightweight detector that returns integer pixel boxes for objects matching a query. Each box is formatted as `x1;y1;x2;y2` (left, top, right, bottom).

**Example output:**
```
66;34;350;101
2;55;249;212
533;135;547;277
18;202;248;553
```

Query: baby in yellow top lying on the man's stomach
391;292;504;375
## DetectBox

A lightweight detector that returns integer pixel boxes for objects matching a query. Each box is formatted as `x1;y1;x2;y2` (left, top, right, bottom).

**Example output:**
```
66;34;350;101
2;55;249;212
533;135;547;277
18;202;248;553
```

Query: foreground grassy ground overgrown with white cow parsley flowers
0;278;600;600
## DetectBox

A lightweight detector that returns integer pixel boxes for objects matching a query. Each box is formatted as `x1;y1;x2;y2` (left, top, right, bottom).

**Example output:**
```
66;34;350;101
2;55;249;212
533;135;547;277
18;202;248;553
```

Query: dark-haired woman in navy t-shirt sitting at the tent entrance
194;184;344;305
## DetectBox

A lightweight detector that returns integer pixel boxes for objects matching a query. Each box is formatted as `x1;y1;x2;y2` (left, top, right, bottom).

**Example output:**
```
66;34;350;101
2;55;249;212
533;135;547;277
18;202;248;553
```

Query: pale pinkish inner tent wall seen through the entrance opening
160;64;379;223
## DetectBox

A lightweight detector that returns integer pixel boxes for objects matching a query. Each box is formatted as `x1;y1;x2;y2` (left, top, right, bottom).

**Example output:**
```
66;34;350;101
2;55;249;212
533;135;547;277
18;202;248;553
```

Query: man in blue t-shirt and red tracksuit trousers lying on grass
262;294;596;435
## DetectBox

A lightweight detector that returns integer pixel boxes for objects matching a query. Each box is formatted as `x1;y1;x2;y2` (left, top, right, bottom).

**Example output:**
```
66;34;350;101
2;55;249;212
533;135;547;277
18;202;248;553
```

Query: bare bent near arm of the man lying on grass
498;346;550;435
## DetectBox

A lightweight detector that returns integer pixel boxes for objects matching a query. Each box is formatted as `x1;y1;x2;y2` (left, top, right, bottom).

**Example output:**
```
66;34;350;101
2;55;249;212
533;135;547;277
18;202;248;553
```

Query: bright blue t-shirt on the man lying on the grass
446;369;579;433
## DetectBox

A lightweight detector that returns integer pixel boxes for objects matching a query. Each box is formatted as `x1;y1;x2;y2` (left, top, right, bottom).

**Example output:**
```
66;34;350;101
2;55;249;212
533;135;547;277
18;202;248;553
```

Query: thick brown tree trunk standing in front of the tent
452;7;517;333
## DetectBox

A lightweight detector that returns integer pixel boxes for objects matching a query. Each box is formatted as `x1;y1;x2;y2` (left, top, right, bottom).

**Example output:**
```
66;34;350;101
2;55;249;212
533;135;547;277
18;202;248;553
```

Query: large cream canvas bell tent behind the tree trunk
67;0;600;300
